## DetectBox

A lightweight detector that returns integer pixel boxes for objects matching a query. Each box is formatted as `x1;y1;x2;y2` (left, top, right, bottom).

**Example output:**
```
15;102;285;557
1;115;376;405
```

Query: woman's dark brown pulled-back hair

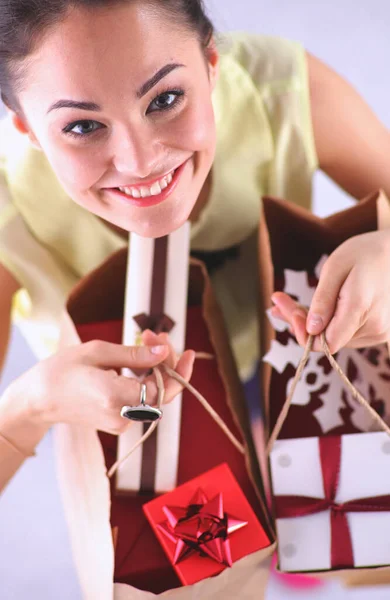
0;0;214;110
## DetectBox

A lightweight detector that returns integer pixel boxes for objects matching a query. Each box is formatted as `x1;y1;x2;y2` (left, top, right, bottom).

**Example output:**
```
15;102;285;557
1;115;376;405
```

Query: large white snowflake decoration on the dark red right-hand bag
263;256;390;434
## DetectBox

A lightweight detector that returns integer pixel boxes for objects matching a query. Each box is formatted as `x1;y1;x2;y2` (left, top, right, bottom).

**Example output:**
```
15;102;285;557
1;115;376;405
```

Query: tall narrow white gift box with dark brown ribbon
116;222;190;493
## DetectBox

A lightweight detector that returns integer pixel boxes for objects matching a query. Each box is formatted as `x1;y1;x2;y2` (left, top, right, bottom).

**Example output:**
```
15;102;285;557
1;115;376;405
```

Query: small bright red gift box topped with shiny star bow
143;463;270;585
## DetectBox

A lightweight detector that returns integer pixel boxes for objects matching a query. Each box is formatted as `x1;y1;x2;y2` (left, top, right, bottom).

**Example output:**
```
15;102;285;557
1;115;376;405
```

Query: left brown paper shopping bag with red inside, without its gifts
56;251;274;600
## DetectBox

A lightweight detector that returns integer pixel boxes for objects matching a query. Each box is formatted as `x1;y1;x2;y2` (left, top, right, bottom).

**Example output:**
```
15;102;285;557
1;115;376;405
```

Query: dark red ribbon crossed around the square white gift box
274;436;390;569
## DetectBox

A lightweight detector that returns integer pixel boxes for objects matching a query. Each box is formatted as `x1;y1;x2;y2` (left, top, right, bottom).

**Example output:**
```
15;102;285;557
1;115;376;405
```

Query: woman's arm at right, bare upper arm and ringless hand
273;55;390;353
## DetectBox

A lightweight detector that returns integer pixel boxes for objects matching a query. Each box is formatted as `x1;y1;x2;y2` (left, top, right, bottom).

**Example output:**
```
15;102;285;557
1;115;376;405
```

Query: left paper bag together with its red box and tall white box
56;224;274;600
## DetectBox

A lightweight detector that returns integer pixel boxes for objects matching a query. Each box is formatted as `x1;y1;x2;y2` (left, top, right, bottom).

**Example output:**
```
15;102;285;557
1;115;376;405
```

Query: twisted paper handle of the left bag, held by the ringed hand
107;352;245;477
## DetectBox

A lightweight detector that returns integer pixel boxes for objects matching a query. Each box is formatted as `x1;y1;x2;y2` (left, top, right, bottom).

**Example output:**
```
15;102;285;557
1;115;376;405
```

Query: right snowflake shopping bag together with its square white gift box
259;194;390;583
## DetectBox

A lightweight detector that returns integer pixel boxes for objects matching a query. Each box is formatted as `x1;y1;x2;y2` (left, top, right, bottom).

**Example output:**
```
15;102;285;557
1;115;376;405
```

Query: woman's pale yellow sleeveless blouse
0;33;317;379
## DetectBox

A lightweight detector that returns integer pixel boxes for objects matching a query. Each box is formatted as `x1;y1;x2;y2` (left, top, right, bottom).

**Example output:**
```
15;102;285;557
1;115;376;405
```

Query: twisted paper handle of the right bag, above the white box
267;332;390;456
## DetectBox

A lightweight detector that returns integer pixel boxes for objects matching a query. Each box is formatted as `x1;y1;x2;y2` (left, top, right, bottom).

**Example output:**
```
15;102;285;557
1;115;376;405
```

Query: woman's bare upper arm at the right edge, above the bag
307;54;390;199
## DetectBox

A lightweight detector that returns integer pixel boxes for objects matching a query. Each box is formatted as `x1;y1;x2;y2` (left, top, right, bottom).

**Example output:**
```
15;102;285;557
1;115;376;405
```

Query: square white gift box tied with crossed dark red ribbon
270;432;390;572
